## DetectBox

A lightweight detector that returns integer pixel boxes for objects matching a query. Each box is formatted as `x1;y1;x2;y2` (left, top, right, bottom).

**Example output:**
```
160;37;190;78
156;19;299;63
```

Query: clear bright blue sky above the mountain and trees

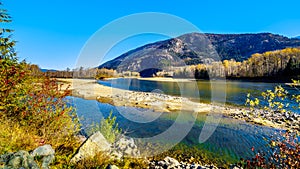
3;0;300;70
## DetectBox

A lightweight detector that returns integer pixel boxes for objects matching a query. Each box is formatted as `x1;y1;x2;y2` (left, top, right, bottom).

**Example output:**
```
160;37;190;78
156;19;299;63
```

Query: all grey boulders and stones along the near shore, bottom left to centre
0;131;225;169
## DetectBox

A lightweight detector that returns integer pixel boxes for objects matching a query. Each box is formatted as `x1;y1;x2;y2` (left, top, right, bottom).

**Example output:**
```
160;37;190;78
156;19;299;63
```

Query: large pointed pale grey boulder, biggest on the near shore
71;131;111;164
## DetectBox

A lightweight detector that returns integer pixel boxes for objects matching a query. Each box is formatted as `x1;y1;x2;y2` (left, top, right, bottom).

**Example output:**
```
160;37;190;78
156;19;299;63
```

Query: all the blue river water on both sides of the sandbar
70;79;297;162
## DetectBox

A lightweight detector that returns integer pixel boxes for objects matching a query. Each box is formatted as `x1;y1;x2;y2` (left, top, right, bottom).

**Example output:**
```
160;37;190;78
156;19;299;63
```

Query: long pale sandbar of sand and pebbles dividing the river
58;78;299;131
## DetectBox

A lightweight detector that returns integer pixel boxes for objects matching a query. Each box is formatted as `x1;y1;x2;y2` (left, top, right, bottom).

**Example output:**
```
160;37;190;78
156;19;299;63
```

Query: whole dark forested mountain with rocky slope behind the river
99;33;300;72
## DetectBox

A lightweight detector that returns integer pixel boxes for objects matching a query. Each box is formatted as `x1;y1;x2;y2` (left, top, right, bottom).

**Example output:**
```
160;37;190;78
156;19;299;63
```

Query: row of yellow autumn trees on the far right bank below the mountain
174;48;300;79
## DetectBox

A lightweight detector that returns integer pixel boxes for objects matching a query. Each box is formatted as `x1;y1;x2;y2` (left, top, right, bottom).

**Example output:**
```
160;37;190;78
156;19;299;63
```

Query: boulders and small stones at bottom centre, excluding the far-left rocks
70;131;234;169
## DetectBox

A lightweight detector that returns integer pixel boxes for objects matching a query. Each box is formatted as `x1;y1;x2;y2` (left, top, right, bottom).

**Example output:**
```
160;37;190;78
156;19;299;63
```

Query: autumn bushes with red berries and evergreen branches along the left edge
0;4;79;165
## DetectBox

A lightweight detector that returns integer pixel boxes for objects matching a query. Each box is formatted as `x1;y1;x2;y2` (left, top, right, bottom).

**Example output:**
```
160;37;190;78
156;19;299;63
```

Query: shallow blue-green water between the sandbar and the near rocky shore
69;97;278;162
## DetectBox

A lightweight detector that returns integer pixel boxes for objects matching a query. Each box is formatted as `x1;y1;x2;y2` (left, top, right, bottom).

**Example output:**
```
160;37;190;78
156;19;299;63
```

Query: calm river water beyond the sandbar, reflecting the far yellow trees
98;78;299;105
